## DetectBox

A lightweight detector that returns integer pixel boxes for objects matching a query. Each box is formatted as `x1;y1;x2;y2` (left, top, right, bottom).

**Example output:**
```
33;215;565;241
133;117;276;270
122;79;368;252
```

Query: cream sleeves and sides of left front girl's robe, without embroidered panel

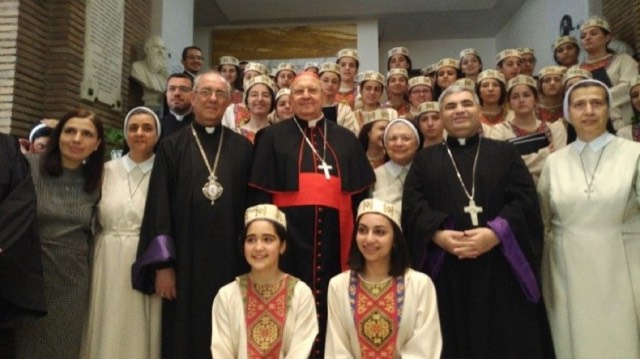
211;278;318;359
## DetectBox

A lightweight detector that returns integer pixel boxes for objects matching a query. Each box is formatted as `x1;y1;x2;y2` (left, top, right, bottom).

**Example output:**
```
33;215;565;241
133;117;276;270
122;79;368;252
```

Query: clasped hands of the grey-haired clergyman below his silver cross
433;227;500;259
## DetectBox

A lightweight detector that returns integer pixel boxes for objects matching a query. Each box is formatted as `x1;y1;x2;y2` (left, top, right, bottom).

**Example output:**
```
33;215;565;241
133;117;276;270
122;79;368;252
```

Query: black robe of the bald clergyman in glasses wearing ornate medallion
133;122;252;358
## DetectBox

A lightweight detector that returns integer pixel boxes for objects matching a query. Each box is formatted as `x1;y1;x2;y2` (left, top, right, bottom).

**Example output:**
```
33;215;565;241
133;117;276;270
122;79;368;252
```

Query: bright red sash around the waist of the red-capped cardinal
273;172;353;271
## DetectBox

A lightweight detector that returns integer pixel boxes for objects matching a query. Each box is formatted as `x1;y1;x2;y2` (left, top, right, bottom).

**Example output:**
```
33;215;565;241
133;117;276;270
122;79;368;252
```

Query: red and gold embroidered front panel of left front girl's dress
239;275;297;359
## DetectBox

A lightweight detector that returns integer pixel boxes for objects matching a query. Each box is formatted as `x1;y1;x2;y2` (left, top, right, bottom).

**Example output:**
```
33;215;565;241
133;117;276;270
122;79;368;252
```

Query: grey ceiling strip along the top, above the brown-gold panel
194;0;526;41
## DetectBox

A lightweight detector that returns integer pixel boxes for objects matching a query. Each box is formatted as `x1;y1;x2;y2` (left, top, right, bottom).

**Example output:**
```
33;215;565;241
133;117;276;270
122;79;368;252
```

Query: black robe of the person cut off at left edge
0;134;47;330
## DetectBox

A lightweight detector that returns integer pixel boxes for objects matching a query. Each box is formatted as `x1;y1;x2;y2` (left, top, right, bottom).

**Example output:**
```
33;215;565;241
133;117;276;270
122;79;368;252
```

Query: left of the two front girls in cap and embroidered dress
211;204;318;359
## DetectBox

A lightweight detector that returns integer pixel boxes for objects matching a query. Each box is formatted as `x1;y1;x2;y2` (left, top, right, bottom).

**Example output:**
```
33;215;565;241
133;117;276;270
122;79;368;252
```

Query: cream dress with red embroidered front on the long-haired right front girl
325;269;442;359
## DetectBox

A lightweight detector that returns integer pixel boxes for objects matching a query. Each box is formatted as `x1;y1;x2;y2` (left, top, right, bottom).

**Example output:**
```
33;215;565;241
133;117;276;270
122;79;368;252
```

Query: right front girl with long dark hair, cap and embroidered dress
325;199;442;359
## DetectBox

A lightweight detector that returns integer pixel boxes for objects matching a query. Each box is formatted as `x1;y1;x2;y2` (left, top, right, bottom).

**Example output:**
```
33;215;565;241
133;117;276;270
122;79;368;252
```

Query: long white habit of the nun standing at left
81;156;162;359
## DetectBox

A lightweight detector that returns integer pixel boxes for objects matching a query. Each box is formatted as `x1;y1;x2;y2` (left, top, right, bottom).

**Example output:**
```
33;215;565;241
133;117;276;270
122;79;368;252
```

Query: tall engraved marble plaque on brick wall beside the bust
80;0;125;111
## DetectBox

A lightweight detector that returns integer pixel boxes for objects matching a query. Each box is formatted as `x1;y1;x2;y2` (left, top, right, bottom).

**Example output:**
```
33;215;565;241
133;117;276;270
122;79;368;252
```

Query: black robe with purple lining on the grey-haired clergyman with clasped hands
402;135;549;358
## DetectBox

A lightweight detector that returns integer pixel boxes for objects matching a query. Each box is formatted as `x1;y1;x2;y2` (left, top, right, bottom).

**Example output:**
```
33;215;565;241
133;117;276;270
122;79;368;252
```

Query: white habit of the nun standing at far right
538;133;640;359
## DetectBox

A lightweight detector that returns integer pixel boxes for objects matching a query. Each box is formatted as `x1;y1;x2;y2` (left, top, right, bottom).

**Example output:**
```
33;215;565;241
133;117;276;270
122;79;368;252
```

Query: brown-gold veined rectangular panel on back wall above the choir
211;24;357;65
